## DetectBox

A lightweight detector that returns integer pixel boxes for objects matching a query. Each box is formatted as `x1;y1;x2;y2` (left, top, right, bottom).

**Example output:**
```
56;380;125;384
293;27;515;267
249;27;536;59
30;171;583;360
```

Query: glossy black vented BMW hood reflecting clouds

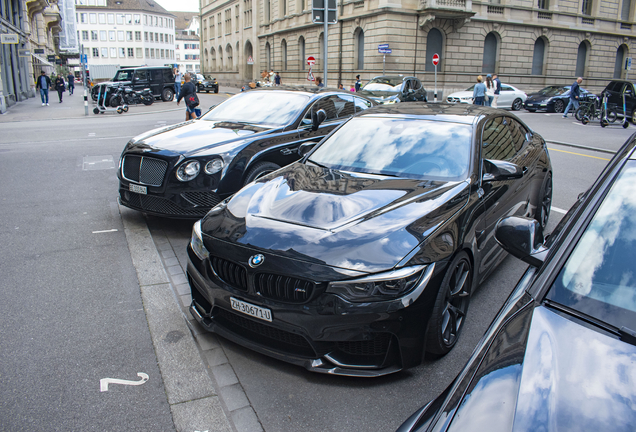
203;163;468;272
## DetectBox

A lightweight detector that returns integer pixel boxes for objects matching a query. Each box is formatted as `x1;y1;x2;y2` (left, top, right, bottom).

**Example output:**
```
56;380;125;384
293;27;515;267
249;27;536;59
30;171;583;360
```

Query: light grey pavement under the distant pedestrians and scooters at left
0;85;241;123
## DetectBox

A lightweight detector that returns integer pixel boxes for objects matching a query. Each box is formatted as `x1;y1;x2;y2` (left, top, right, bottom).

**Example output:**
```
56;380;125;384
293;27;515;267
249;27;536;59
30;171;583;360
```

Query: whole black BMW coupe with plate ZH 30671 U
187;103;552;376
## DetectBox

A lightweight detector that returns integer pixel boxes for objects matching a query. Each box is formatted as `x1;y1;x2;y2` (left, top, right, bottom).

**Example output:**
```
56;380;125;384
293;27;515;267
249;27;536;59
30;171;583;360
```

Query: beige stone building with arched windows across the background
201;0;636;97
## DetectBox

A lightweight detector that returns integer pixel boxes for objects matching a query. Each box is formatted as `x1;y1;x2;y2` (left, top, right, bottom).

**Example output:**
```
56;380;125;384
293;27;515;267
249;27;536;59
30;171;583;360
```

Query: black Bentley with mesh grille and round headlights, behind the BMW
118;87;373;219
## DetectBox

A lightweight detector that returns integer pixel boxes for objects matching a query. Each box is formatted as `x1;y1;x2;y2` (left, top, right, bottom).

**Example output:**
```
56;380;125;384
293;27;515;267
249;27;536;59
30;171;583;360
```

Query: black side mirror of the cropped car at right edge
495;216;548;267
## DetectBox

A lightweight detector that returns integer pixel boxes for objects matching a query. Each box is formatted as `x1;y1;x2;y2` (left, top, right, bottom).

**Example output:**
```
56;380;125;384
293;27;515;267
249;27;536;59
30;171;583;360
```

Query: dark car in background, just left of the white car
356;75;426;104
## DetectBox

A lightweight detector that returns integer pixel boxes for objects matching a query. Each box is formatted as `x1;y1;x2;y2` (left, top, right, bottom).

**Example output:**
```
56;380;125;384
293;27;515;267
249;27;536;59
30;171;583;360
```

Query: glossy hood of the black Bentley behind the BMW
125;120;271;157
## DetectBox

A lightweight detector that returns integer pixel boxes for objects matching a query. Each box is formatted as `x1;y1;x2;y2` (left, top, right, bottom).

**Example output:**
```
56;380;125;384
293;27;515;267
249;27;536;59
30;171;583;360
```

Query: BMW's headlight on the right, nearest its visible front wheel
327;265;426;302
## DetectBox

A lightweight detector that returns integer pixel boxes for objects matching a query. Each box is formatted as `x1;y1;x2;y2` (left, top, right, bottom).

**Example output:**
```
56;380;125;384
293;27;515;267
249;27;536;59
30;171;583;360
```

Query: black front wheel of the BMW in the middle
426;251;472;356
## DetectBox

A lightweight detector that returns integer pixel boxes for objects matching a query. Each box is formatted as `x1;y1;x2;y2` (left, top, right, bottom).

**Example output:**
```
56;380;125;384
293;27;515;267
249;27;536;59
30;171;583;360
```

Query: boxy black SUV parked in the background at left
113;66;174;102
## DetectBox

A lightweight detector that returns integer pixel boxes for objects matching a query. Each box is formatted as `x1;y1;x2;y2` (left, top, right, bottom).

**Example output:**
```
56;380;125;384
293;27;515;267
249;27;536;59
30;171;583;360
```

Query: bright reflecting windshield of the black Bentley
202;91;309;127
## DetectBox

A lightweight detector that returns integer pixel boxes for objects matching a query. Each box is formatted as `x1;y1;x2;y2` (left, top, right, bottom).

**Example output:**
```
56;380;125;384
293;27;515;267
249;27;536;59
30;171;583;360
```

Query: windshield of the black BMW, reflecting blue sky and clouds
308;115;472;180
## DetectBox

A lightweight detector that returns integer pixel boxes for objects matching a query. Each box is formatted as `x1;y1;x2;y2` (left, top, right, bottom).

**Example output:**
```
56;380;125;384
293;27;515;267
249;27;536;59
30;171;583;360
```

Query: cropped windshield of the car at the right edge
547;160;636;329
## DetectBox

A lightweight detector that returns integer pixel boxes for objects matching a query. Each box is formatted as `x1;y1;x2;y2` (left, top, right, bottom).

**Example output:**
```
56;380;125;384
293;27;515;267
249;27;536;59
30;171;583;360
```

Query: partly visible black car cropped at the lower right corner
399;135;636;432
